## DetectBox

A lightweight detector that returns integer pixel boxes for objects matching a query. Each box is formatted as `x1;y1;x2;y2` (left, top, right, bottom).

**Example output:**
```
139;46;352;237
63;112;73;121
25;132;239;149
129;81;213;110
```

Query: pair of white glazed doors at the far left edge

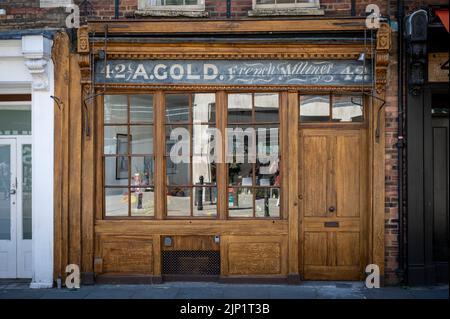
0;137;32;278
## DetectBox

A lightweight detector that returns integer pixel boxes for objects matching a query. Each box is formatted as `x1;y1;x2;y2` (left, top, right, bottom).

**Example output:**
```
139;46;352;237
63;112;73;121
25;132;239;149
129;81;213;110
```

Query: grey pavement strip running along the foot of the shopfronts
0;280;449;299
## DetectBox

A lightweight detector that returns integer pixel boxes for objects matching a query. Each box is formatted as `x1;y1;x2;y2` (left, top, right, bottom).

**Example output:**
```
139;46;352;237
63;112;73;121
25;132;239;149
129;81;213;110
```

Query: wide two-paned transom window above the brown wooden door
299;94;364;123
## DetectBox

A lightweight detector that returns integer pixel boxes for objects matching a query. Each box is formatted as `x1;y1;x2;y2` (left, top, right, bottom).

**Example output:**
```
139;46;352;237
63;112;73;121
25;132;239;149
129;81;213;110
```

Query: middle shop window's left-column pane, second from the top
166;125;191;157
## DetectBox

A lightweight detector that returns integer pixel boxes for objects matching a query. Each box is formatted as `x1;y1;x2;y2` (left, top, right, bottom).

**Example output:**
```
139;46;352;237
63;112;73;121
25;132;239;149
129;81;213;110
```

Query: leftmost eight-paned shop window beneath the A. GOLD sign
103;94;155;217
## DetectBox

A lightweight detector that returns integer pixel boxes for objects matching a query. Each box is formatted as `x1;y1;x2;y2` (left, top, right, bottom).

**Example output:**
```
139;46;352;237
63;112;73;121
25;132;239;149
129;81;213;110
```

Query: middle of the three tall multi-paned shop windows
165;93;217;217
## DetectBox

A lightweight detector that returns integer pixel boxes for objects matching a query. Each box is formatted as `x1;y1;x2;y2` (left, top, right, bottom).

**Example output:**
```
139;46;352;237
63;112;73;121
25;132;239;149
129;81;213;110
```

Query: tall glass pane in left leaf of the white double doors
0;145;11;240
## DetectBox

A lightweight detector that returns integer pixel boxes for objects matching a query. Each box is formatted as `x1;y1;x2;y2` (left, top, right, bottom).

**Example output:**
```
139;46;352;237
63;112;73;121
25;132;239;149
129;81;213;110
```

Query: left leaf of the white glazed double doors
0;139;17;278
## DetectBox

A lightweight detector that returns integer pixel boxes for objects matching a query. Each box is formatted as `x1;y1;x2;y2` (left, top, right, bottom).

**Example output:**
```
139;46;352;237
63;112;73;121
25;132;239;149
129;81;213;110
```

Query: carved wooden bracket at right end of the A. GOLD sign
375;23;391;94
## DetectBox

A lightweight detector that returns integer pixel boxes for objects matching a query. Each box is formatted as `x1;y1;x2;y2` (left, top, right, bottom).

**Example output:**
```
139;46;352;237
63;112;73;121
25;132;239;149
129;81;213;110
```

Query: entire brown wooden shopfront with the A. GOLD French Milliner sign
53;19;390;283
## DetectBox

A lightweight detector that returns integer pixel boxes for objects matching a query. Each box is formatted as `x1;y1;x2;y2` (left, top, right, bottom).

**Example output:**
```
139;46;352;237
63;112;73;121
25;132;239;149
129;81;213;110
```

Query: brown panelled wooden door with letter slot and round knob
299;129;368;280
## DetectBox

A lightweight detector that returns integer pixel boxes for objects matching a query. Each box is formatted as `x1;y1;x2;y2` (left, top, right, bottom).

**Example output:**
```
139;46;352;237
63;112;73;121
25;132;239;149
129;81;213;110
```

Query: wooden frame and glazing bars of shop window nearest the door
227;90;284;220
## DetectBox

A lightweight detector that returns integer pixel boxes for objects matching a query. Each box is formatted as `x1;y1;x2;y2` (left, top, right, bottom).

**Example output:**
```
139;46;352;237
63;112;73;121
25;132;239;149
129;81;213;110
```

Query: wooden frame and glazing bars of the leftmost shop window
99;92;158;220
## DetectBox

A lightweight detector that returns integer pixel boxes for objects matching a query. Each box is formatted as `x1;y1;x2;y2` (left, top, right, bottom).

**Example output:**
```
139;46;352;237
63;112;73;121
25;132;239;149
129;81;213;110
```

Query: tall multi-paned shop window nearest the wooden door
227;93;281;218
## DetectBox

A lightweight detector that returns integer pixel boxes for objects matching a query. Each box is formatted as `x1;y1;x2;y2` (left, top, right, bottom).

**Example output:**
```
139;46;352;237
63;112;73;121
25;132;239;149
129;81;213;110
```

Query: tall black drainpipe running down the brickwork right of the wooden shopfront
397;0;408;282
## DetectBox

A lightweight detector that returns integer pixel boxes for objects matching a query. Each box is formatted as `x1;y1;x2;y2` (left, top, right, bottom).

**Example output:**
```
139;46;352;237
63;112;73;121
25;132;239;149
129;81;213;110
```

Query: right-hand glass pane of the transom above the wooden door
332;95;364;122
